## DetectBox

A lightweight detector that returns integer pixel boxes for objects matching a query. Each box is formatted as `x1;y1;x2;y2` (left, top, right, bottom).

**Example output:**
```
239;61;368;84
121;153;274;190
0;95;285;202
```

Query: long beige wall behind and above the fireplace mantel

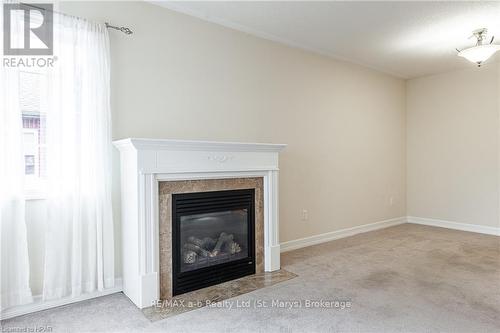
61;2;406;241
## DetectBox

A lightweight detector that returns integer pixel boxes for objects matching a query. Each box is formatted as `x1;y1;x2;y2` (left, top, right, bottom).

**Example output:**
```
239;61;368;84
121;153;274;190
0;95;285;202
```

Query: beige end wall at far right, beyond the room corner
407;64;500;227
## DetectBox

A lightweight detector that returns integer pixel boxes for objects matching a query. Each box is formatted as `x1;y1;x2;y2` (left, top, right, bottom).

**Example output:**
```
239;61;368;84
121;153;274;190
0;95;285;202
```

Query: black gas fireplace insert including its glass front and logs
172;189;255;295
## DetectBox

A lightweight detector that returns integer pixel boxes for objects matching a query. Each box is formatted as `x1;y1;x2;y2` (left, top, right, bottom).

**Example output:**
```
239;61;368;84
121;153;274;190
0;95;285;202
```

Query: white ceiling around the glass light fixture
156;1;500;78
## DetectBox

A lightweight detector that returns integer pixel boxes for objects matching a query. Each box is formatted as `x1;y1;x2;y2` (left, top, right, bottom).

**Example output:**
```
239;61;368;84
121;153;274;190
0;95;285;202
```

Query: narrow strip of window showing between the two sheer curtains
19;69;46;197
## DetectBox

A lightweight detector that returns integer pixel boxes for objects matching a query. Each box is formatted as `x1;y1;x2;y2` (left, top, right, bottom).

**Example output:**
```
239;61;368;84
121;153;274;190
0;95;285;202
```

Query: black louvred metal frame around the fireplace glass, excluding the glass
172;189;255;296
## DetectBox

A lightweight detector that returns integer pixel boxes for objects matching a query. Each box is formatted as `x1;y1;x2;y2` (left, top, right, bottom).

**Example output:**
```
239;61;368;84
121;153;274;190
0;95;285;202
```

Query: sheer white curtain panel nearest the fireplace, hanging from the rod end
43;14;114;300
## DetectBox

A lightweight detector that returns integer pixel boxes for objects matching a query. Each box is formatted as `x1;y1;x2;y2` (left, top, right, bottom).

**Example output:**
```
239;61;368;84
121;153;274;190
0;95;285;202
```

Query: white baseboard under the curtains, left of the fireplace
0;278;123;320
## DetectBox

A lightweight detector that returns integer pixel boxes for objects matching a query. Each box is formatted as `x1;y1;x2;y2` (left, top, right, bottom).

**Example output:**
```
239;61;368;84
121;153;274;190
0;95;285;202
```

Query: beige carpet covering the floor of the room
2;224;500;333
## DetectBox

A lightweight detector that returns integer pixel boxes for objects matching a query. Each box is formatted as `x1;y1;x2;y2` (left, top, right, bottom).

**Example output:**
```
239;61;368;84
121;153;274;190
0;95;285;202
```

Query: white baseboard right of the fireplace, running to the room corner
280;216;406;253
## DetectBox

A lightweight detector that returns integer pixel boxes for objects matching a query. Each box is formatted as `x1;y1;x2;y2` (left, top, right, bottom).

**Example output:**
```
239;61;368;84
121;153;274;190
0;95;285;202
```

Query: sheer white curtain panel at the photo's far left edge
0;6;32;310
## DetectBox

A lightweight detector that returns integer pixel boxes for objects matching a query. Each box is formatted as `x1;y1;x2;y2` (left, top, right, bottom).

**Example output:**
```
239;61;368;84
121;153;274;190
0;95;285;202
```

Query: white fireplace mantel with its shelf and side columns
114;138;286;308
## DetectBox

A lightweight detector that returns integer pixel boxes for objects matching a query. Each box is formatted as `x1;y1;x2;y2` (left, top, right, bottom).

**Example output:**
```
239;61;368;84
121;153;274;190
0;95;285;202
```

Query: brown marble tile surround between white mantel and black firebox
159;177;264;300
